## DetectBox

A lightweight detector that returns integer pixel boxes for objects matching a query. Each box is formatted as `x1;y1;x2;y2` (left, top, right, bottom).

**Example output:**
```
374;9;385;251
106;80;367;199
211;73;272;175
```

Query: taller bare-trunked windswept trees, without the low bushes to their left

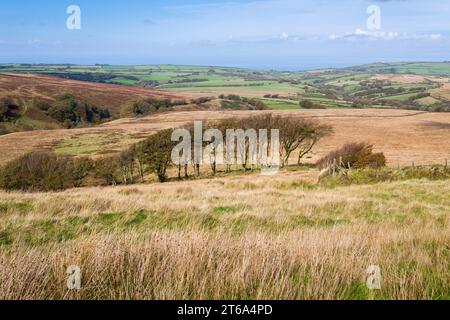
110;114;332;183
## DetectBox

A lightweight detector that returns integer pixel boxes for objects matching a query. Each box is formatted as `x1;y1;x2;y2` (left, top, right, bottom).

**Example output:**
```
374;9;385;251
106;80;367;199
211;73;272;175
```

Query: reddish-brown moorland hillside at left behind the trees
0;74;184;134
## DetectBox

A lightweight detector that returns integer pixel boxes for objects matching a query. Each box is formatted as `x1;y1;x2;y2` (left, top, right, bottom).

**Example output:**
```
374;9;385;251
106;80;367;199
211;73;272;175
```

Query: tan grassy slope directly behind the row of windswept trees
0;109;450;166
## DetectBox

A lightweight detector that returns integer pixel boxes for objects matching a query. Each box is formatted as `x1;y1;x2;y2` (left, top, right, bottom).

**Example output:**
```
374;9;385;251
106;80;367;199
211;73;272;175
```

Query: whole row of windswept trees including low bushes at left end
0;114;332;191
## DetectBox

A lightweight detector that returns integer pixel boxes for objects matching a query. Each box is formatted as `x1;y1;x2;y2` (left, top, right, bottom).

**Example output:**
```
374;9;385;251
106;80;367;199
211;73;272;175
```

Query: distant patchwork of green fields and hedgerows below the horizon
0;62;450;111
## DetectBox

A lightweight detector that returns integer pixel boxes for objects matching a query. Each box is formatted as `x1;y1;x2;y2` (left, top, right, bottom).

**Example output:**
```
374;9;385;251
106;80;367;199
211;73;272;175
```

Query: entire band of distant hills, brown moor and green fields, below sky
0;62;450;134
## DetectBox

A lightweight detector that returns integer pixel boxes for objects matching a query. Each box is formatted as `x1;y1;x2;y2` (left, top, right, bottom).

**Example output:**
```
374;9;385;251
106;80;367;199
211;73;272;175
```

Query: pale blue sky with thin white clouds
0;0;450;70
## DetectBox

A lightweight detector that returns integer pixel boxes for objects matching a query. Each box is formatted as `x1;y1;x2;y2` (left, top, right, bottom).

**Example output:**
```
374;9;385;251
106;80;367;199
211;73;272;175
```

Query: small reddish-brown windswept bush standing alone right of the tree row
317;142;386;170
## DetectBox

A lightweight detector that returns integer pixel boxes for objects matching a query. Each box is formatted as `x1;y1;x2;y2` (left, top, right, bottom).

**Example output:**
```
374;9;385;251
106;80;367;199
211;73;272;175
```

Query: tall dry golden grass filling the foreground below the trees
0;171;450;299
